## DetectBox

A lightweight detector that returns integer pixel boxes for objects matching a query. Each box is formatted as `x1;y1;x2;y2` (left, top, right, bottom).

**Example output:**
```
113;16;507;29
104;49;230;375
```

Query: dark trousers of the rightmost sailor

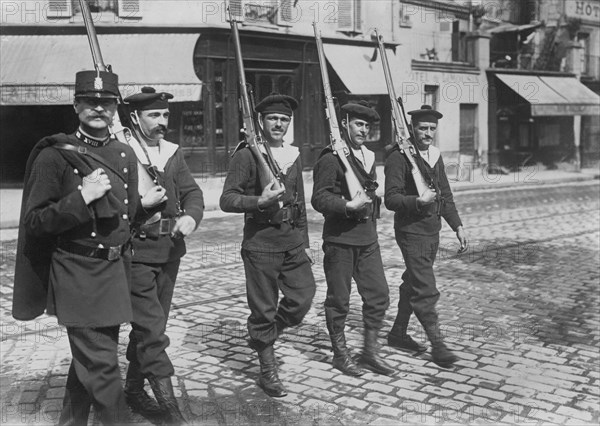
396;231;440;324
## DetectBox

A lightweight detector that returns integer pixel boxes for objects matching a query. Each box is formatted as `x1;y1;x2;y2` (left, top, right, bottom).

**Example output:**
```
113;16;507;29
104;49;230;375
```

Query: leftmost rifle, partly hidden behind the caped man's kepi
79;0;158;195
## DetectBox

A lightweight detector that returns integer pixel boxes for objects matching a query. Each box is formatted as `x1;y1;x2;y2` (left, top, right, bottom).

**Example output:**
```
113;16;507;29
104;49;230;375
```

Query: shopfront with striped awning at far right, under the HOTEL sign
488;70;600;169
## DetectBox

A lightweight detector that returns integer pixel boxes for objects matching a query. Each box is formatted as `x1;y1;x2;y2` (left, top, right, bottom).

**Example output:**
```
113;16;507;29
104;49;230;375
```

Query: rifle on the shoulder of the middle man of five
227;6;283;191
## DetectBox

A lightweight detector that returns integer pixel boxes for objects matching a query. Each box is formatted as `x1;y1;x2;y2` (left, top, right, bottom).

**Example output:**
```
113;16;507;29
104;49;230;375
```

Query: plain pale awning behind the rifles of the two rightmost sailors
323;43;397;95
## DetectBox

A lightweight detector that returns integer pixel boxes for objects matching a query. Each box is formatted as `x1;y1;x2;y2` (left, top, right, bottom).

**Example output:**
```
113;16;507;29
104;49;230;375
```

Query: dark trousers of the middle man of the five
242;246;316;349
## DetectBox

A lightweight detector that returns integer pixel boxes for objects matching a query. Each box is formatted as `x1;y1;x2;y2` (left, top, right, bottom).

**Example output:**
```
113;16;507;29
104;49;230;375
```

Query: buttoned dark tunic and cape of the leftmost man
13;134;141;327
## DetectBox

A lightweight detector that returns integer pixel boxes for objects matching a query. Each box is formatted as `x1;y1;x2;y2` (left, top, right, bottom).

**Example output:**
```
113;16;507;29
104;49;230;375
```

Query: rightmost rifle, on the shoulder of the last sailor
375;28;432;196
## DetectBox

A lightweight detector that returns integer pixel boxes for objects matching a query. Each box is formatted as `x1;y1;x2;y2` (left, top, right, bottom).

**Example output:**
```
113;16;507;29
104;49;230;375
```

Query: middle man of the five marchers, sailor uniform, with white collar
220;94;315;397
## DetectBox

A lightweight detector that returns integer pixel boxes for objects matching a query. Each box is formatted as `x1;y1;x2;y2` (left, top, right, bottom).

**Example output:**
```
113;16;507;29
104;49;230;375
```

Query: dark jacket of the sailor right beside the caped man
133;145;204;263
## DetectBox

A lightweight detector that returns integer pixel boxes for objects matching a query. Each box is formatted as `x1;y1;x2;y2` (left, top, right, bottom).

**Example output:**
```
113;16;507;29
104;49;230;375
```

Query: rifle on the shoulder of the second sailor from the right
313;22;368;212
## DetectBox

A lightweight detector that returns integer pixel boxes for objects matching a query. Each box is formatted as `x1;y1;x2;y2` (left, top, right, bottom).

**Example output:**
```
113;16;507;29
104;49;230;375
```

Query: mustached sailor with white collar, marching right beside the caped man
125;87;204;424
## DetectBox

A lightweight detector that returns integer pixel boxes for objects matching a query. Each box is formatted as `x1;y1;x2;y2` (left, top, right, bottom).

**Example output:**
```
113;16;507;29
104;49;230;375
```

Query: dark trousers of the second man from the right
323;242;390;334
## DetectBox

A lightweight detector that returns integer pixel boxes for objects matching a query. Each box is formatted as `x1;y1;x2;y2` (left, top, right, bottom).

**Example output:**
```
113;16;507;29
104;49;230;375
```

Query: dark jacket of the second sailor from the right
311;148;379;246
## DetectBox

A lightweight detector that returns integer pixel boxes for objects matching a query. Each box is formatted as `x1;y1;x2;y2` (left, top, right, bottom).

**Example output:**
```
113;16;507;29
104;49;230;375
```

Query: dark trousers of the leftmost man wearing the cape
59;325;129;426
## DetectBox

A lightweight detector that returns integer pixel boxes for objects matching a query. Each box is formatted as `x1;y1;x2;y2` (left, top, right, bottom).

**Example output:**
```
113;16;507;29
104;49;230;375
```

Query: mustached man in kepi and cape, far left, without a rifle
13;71;161;425
